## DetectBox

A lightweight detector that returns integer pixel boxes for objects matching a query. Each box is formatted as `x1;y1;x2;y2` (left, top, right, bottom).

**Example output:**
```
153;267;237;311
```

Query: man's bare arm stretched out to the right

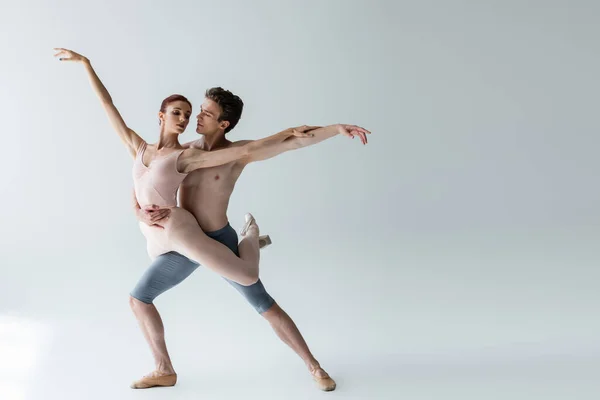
241;124;371;163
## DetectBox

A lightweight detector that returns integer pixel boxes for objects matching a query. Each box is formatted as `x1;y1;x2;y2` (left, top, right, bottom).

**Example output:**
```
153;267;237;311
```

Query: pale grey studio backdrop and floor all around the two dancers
0;0;600;400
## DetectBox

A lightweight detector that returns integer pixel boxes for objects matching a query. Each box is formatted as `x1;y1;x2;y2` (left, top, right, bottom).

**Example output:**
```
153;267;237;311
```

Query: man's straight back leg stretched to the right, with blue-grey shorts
206;225;336;391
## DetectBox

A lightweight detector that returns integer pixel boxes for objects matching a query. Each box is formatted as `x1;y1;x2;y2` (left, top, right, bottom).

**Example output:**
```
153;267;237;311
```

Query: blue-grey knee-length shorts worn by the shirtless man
130;224;275;314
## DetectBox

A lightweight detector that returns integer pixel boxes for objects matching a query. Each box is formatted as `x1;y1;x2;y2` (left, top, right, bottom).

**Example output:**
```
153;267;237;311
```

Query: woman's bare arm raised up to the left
54;48;144;157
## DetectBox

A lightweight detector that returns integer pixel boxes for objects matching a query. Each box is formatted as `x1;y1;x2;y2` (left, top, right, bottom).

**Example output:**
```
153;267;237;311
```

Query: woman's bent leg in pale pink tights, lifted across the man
159;208;260;286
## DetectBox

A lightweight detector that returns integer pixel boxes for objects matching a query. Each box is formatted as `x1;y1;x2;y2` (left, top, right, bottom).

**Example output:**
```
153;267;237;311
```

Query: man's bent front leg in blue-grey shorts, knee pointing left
129;252;198;389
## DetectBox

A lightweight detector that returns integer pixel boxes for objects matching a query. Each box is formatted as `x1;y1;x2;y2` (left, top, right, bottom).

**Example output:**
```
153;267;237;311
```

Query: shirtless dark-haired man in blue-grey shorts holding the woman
130;88;370;391
